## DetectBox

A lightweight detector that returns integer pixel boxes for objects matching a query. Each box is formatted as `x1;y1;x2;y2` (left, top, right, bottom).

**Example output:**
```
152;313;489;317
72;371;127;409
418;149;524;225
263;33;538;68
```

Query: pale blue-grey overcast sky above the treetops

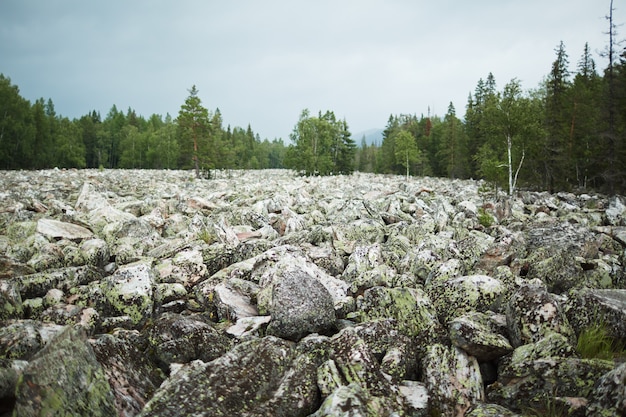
0;0;626;141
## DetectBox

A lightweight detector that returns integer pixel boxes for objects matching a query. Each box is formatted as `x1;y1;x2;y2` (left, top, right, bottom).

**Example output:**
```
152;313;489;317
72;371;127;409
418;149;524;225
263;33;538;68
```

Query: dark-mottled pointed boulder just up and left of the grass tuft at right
505;280;575;347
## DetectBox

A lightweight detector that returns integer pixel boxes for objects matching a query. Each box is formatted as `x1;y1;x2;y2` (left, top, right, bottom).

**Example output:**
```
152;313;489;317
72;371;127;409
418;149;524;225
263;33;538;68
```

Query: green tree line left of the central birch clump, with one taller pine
0;74;286;174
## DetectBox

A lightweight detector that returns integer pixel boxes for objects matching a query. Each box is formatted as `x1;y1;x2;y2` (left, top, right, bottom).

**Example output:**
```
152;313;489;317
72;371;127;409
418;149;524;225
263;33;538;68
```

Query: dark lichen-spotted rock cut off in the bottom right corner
587;363;626;417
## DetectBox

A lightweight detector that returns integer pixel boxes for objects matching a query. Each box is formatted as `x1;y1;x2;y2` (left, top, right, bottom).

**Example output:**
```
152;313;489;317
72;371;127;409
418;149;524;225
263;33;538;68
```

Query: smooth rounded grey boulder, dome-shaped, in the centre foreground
267;268;336;341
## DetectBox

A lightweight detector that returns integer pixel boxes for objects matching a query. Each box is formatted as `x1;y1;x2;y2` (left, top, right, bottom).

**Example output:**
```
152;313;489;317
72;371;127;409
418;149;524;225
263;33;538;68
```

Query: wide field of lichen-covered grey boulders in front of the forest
0;170;626;417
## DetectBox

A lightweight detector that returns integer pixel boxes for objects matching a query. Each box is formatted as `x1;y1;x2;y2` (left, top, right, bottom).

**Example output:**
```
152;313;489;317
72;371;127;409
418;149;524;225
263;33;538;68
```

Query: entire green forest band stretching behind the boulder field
0;35;626;194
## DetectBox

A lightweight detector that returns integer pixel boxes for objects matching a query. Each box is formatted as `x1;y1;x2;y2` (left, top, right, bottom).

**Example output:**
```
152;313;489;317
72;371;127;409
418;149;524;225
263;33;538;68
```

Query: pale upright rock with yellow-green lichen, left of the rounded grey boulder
101;262;155;326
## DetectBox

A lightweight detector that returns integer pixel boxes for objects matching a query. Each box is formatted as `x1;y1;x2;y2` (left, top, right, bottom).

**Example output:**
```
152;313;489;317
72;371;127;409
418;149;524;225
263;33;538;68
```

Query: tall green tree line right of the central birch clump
355;37;626;193
